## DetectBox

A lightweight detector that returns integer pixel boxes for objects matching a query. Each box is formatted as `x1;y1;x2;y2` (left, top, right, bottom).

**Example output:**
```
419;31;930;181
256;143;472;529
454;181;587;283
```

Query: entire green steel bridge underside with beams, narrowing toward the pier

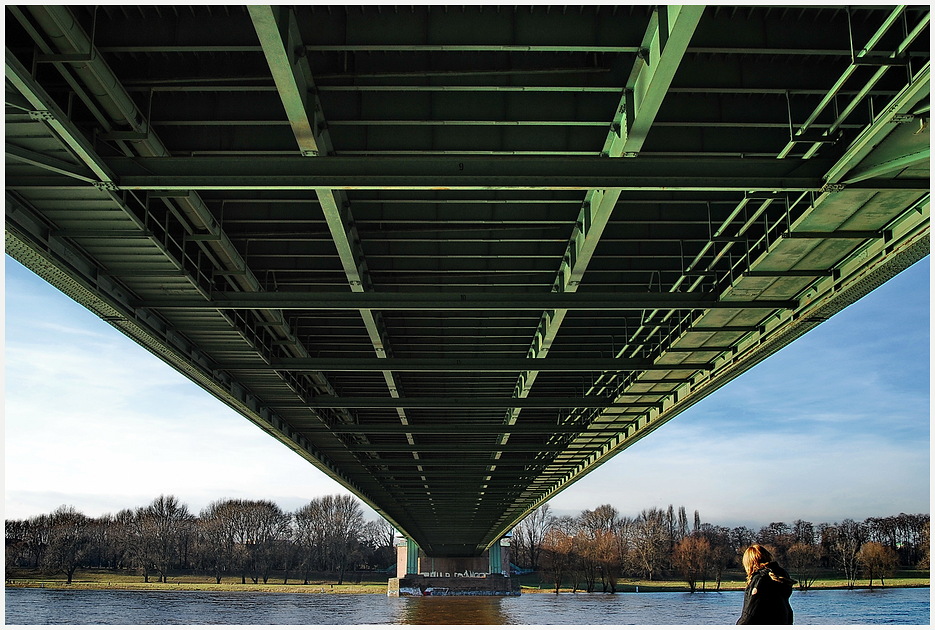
5;5;929;557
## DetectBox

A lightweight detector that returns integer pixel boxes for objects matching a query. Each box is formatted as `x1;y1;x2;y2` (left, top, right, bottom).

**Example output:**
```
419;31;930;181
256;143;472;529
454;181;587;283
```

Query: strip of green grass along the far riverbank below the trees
6;569;930;595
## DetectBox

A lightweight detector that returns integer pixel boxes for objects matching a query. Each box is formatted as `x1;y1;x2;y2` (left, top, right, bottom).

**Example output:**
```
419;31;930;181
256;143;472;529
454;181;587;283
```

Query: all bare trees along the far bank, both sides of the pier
5;495;929;592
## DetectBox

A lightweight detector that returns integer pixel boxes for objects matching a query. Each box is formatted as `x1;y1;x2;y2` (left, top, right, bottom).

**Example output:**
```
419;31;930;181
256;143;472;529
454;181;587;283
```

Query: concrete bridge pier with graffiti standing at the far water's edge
386;538;520;597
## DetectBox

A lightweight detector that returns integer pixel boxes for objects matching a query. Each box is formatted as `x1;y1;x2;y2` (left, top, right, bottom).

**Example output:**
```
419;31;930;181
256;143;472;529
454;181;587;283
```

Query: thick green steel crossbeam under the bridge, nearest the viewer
58;155;836;193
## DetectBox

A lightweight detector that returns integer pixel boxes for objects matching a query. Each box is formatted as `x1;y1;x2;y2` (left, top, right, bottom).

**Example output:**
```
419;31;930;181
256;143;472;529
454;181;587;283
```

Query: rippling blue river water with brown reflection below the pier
5;588;930;625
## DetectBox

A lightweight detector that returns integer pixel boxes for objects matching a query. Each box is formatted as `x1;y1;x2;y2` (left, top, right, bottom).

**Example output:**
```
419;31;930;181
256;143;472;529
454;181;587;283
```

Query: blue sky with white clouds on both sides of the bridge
4;257;930;528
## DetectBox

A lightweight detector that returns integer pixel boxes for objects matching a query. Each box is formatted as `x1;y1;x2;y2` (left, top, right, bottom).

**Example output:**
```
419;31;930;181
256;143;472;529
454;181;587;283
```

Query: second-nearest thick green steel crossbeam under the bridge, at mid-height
135;291;798;311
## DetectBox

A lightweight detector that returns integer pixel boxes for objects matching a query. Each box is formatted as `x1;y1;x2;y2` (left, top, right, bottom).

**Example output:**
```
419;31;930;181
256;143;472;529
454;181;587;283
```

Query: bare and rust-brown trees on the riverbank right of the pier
511;503;929;593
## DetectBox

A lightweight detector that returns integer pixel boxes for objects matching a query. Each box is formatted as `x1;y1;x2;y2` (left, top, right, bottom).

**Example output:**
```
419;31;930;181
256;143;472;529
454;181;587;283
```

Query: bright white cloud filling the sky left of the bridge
4;270;347;518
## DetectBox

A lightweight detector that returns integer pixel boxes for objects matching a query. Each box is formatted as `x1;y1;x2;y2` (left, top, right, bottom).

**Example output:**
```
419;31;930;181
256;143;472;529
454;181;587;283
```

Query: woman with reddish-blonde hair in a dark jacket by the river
737;545;795;625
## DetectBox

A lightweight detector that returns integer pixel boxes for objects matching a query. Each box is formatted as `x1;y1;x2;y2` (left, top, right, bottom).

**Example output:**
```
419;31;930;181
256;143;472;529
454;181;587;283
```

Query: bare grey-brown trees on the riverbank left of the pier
5;495;395;584
